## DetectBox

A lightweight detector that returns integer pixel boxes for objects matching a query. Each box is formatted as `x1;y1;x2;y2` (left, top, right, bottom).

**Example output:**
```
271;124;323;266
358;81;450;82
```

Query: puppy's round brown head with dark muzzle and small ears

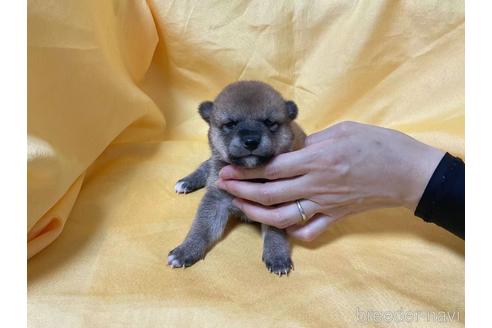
199;81;297;168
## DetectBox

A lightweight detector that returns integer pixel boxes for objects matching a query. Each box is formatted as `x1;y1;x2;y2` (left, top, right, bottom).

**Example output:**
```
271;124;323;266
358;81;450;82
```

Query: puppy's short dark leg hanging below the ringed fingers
261;224;293;276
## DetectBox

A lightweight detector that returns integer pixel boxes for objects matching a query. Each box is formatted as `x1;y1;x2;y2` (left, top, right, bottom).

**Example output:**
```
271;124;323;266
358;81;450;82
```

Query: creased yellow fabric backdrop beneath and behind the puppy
27;0;464;327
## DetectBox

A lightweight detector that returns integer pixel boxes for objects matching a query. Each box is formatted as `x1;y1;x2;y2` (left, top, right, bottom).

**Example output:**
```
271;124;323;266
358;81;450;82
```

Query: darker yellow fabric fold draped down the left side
27;0;163;256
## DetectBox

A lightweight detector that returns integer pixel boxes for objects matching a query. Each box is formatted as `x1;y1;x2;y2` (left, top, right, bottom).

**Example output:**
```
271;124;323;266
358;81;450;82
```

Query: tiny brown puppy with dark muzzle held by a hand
168;81;305;276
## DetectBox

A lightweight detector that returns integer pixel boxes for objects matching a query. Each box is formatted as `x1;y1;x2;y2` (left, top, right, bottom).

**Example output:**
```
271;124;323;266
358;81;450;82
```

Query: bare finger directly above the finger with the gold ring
217;176;310;205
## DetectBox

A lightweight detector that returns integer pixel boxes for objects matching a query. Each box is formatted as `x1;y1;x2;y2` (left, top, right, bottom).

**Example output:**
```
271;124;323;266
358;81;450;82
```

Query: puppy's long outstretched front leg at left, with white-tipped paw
167;189;231;268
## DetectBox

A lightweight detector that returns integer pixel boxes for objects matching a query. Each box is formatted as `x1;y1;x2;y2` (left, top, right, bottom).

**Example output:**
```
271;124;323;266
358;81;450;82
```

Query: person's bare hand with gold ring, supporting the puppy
217;122;445;241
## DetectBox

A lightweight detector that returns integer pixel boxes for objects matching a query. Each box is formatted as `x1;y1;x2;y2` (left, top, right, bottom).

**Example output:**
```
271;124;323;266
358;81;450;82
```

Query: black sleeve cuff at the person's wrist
415;153;465;239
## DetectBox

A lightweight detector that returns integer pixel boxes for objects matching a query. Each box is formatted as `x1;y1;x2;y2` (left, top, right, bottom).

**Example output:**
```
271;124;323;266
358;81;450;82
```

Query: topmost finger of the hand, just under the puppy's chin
219;149;311;180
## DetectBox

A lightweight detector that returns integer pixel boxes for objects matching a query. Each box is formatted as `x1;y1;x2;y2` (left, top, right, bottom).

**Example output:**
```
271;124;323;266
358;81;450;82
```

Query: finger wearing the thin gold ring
233;198;320;229
